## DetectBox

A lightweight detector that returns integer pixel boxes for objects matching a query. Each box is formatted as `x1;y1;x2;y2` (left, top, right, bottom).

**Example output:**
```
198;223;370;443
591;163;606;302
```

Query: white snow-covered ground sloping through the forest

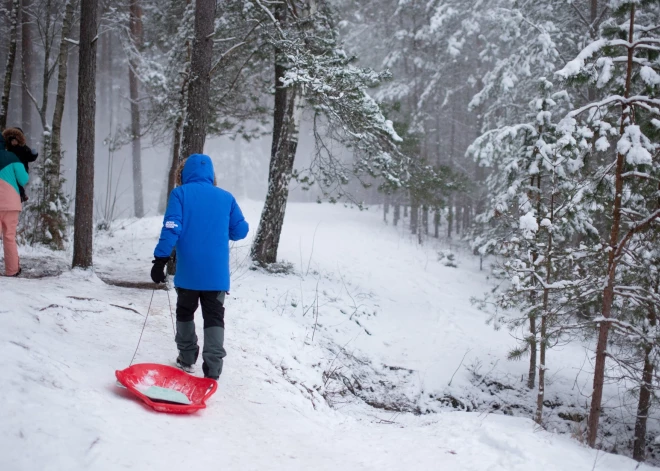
0;202;655;471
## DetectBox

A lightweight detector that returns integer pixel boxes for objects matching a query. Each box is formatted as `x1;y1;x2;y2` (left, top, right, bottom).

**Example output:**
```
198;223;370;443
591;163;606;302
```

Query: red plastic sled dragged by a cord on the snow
115;363;218;414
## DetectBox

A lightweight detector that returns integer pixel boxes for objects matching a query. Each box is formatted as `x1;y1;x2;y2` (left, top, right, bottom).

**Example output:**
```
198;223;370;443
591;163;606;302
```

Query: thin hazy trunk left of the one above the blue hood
128;0;144;218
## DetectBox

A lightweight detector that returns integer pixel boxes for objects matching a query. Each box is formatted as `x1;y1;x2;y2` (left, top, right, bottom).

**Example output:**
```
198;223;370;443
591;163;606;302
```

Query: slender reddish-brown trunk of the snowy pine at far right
587;4;635;447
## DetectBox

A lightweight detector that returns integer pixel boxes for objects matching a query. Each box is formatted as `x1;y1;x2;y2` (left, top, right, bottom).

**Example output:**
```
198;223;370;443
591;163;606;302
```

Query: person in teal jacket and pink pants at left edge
0;136;30;276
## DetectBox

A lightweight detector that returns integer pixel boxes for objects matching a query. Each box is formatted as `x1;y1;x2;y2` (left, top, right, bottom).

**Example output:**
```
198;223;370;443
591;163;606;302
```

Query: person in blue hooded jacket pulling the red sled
151;154;249;380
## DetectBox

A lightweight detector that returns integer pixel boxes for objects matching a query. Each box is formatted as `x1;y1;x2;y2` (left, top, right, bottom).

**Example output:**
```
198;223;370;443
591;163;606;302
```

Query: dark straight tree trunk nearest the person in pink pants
73;0;98;268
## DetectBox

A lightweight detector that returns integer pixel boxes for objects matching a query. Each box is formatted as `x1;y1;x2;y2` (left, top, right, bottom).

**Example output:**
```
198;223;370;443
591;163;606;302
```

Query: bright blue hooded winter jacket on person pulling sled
154;154;249;291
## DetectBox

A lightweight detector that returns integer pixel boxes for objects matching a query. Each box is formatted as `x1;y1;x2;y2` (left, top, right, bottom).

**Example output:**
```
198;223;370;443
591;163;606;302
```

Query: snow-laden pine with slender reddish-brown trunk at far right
558;1;660;446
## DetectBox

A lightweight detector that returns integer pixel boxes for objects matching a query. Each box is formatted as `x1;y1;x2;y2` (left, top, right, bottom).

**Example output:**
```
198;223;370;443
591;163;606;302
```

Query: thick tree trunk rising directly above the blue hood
181;0;215;158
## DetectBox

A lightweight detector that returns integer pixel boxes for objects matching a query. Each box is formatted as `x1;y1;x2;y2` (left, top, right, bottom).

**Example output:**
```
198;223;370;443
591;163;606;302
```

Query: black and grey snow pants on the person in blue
175;288;227;379
